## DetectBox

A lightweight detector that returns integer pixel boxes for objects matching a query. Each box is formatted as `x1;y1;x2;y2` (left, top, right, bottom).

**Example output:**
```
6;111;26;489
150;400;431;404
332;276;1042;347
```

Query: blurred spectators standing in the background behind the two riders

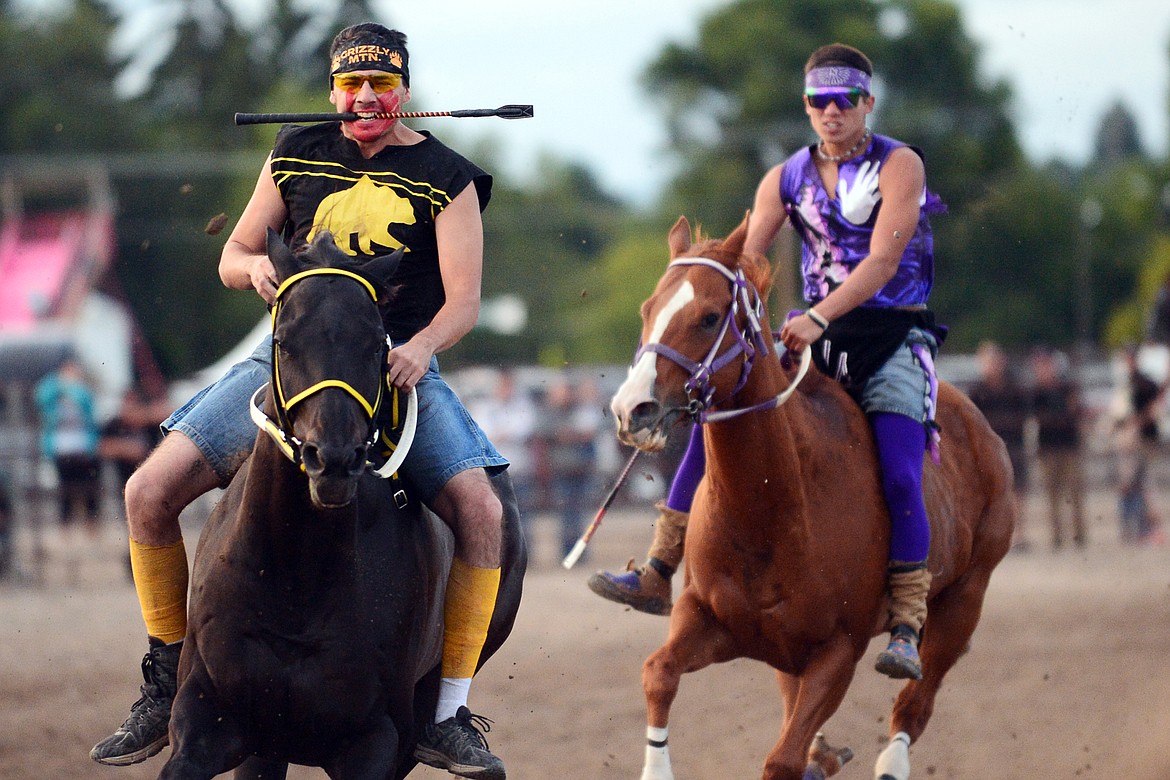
0;339;1170;577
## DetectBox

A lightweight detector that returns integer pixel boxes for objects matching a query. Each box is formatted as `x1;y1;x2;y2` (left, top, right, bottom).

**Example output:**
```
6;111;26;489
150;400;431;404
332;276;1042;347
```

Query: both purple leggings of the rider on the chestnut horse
666;413;930;562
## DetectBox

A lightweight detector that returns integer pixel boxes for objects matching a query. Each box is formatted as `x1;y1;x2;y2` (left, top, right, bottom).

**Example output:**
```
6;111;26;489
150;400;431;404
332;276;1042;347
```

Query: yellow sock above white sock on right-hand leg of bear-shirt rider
442;558;500;678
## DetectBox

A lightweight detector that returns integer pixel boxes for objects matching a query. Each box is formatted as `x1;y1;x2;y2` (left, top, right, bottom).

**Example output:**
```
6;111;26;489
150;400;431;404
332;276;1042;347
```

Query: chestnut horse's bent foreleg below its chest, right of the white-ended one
764;635;865;780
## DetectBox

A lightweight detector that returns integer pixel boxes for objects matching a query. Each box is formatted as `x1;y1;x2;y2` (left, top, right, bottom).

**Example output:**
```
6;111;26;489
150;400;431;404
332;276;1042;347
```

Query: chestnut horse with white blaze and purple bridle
612;218;1016;780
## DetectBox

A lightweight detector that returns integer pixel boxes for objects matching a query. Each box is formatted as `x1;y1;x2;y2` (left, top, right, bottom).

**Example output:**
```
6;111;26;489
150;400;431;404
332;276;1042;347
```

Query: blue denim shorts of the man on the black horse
163;337;508;503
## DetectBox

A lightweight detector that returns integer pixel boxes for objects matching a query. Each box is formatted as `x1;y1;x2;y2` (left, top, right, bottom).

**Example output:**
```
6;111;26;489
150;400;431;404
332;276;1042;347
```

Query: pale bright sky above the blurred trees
47;0;1170;202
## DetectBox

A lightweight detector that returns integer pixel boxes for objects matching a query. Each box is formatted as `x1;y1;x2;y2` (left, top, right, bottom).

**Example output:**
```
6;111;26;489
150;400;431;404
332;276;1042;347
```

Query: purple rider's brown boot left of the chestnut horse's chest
589;502;690;615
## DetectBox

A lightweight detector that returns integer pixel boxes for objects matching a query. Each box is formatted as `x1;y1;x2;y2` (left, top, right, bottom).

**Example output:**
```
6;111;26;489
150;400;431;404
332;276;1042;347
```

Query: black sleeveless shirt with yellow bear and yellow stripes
271;122;491;343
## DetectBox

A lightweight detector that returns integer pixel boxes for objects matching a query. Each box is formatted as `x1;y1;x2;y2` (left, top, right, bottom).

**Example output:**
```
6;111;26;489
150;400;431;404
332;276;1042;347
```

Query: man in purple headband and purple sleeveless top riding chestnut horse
590;43;944;679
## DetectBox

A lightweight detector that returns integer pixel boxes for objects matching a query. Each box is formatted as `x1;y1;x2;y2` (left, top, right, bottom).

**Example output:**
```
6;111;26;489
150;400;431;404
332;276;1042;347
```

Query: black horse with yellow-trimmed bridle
159;232;527;780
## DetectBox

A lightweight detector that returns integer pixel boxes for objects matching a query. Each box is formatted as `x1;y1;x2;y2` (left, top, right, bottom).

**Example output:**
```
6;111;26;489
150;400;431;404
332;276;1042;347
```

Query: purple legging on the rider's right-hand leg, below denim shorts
869;412;930;564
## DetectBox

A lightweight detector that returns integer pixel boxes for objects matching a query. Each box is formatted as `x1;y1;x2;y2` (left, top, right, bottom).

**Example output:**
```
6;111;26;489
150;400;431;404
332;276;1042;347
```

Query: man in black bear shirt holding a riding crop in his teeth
90;23;508;780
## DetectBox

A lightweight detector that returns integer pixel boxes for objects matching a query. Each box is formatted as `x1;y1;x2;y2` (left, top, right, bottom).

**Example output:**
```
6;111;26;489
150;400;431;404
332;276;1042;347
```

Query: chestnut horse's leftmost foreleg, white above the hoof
641;589;735;780
